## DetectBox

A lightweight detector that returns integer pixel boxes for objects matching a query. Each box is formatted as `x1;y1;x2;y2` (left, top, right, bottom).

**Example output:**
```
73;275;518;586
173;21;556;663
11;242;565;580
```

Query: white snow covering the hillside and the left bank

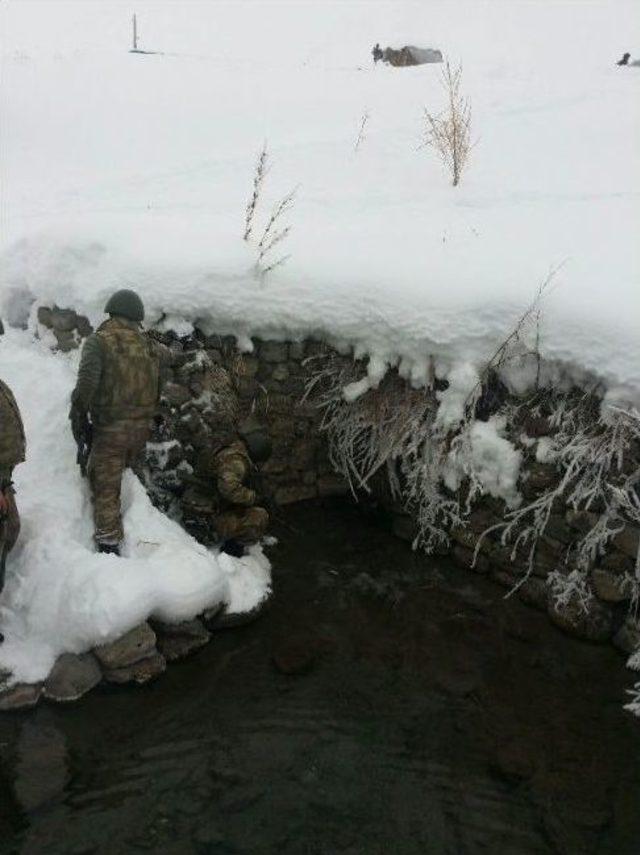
0;0;640;679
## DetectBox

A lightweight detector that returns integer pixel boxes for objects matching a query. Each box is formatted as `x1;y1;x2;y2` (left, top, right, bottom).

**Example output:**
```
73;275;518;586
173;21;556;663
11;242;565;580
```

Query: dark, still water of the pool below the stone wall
0;505;640;855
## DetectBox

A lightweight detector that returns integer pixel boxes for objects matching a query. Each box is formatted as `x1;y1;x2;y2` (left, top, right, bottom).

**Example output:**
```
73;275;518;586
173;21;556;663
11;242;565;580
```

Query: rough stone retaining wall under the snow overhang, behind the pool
38;308;640;652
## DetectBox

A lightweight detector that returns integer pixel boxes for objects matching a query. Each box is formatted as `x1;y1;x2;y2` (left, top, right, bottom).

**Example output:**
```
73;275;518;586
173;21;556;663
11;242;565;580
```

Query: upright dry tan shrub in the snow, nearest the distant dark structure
424;60;472;187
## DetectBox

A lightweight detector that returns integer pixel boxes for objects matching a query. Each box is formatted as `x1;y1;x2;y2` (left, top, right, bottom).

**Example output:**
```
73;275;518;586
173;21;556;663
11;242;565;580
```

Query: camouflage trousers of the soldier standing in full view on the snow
88;419;151;545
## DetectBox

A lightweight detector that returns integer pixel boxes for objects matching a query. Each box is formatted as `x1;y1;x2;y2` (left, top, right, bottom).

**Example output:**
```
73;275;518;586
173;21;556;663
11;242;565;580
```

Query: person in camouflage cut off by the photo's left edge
0;380;26;612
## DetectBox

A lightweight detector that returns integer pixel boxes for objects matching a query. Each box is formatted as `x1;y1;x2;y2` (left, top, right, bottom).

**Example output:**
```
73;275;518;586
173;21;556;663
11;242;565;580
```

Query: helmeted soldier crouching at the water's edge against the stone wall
183;418;271;557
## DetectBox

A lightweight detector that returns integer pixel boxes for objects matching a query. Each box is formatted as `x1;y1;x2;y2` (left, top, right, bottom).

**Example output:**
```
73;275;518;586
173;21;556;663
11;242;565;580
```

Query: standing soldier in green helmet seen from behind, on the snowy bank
69;289;163;555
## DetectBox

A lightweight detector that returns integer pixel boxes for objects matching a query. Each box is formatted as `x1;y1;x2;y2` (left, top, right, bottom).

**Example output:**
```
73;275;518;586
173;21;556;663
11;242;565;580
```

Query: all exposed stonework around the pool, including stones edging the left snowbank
5;306;640;709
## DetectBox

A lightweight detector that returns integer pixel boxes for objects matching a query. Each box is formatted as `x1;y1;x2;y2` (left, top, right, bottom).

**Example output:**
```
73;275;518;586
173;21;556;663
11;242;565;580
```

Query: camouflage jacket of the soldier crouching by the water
195;439;256;507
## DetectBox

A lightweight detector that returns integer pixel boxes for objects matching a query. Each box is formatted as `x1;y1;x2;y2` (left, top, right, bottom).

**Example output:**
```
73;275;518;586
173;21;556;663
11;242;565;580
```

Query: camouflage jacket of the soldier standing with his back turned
71;317;168;425
